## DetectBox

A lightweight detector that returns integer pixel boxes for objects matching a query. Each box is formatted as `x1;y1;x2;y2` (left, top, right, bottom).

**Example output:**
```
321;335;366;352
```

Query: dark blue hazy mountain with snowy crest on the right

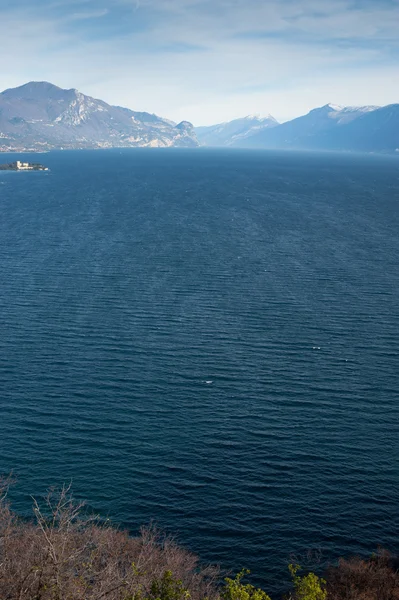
233;104;399;152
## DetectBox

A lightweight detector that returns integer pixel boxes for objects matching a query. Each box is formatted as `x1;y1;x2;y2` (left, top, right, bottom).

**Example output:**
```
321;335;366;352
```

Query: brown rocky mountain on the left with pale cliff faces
0;81;198;151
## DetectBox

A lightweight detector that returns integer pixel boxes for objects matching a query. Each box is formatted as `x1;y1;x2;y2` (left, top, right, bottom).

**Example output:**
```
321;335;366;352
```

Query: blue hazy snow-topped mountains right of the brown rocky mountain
196;104;399;152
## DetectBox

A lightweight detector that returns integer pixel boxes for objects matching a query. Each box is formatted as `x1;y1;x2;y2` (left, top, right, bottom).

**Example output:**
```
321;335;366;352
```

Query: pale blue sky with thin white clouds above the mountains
0;0;399;126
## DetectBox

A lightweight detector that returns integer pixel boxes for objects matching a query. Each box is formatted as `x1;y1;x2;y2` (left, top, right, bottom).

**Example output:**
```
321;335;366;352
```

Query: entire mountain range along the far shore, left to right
0;82;399;152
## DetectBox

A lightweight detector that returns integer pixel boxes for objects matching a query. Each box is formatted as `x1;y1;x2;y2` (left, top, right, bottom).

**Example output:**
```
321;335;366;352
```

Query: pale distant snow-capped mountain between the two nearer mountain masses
195;115;278;146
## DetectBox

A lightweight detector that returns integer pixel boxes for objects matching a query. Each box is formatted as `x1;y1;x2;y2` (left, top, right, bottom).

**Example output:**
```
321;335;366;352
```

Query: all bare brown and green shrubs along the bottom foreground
0;482;399;600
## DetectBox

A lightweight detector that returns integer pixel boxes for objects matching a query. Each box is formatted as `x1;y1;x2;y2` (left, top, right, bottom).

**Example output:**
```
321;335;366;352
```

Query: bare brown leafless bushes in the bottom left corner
0;481;219;600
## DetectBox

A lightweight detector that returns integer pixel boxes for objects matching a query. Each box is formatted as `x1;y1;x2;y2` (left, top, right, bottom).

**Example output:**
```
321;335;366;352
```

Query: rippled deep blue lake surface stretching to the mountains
0;149;399;590
